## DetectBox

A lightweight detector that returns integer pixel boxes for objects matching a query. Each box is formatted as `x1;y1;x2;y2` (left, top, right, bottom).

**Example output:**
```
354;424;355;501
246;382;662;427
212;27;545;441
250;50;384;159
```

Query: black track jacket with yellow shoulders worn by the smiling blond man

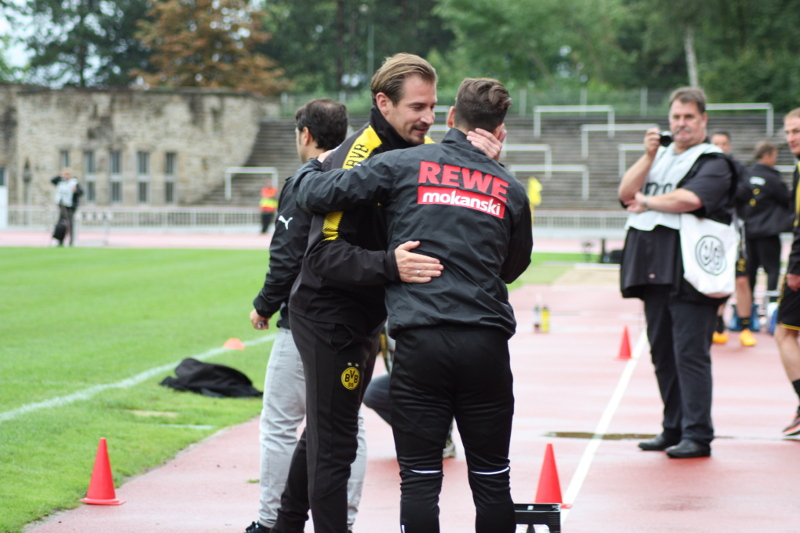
289;108;424;333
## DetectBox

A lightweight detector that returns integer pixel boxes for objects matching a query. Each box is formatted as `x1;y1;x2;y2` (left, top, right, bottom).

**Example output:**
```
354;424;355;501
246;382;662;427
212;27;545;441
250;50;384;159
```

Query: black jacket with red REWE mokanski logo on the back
297;129;533;336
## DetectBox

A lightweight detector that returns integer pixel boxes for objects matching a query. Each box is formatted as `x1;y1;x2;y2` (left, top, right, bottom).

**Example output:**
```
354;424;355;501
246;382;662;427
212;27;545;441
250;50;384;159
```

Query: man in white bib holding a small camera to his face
618;87;736;459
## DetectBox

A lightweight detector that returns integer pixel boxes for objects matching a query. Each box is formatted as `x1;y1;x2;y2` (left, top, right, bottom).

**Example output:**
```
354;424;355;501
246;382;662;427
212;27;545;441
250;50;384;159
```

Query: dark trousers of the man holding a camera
643;285;718;444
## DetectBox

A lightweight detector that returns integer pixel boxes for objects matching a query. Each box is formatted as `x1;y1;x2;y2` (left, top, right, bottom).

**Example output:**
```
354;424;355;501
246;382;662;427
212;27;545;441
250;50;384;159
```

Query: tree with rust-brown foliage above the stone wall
134;0;288;95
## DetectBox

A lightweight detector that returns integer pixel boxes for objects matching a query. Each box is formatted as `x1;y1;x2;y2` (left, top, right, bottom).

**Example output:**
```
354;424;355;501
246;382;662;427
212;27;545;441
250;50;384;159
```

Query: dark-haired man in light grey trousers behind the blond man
245;99;367;533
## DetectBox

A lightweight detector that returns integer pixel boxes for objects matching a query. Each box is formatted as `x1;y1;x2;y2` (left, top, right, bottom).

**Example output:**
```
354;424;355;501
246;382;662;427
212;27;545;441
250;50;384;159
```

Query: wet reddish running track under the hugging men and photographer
20;246;800;533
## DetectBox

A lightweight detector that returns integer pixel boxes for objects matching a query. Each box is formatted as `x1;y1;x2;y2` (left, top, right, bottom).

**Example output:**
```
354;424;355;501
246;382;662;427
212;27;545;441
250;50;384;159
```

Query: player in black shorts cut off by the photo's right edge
775;107;800;437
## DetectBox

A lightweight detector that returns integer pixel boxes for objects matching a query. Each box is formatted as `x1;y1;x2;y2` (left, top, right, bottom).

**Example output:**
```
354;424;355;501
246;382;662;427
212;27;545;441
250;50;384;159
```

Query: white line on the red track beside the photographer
561;332;648;524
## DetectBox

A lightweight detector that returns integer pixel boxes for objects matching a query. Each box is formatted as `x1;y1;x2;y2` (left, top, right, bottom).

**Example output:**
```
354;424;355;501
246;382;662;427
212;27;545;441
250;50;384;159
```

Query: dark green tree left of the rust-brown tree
9;0;153;87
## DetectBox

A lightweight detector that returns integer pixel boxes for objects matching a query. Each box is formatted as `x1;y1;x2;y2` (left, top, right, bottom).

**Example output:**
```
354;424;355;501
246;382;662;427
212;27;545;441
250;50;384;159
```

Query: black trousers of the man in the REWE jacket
390;328;516;533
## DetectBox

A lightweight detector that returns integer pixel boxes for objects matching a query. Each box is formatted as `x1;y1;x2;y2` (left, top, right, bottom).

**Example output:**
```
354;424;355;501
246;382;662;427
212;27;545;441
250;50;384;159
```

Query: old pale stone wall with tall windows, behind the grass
7;87;276;206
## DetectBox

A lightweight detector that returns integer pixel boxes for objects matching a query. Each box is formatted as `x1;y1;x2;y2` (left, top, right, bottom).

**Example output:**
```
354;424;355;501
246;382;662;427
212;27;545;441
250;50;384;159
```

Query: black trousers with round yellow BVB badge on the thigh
272;315;380;533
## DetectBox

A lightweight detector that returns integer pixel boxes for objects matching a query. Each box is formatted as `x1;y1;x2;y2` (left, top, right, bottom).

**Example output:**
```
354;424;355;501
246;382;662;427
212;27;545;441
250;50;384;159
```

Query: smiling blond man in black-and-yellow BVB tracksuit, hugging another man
271;54;501;533
